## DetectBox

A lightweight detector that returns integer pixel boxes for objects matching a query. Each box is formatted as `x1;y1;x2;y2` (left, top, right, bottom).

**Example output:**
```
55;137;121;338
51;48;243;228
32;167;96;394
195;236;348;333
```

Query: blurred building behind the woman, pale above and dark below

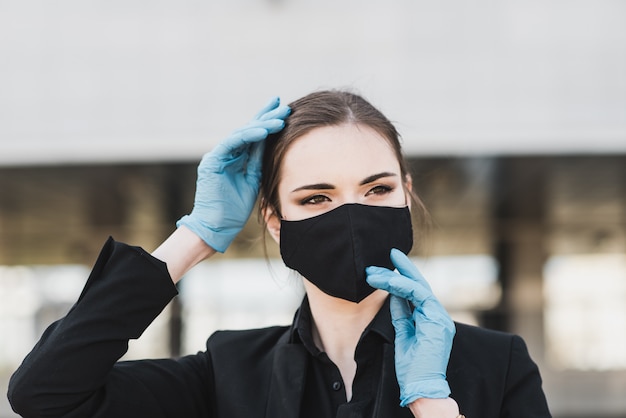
0;0;626;418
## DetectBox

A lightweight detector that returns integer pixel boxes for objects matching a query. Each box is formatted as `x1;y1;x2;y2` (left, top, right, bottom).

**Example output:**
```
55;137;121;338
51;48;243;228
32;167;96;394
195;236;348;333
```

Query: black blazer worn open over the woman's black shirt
8;240;550;418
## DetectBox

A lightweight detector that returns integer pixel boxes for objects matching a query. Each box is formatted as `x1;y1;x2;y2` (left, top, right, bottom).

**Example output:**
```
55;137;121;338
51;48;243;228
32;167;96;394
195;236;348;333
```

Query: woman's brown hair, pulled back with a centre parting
259;90;424;216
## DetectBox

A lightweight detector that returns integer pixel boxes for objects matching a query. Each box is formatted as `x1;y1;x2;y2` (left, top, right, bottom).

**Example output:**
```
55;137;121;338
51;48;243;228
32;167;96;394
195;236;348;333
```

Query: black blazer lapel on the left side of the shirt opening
265;344;308;418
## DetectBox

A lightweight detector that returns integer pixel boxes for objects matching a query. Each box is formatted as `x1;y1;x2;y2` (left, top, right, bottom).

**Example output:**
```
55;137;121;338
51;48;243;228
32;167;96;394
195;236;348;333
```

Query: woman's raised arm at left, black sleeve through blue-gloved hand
8;99;289;418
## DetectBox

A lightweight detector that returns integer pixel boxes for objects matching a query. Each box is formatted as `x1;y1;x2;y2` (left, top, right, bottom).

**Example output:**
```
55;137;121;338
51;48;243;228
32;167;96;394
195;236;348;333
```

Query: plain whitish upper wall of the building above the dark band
0;0;626;165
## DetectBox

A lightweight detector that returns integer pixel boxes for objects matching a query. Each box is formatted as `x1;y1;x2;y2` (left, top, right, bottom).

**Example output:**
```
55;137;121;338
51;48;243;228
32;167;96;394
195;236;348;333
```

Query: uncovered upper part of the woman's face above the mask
278;124;410;224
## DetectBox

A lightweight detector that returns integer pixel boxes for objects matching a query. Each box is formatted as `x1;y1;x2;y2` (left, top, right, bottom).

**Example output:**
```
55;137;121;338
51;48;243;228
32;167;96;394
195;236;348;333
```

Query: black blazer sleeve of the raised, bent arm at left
8;239;212;418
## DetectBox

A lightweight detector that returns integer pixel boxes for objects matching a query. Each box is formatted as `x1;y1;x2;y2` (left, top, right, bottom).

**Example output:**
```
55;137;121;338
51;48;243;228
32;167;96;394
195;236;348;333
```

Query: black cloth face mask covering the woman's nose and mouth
280;203;413;303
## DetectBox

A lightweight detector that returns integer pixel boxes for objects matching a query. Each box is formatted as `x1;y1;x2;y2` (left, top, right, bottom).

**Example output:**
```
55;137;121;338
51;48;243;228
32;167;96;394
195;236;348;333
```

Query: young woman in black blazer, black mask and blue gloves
9;91;550;418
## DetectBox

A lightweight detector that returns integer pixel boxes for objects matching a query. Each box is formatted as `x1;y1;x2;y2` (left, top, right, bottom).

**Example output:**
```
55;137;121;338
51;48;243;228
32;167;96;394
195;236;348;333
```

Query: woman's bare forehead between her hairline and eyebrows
281;124;400;183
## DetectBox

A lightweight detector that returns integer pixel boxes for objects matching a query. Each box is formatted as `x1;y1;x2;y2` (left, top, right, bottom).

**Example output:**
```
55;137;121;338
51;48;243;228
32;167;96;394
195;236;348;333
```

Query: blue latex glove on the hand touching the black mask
365;249;456;406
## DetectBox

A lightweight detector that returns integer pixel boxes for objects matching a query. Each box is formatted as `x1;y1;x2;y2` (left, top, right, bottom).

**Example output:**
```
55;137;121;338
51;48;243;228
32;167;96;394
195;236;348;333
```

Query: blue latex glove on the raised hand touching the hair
176;97;291;252
